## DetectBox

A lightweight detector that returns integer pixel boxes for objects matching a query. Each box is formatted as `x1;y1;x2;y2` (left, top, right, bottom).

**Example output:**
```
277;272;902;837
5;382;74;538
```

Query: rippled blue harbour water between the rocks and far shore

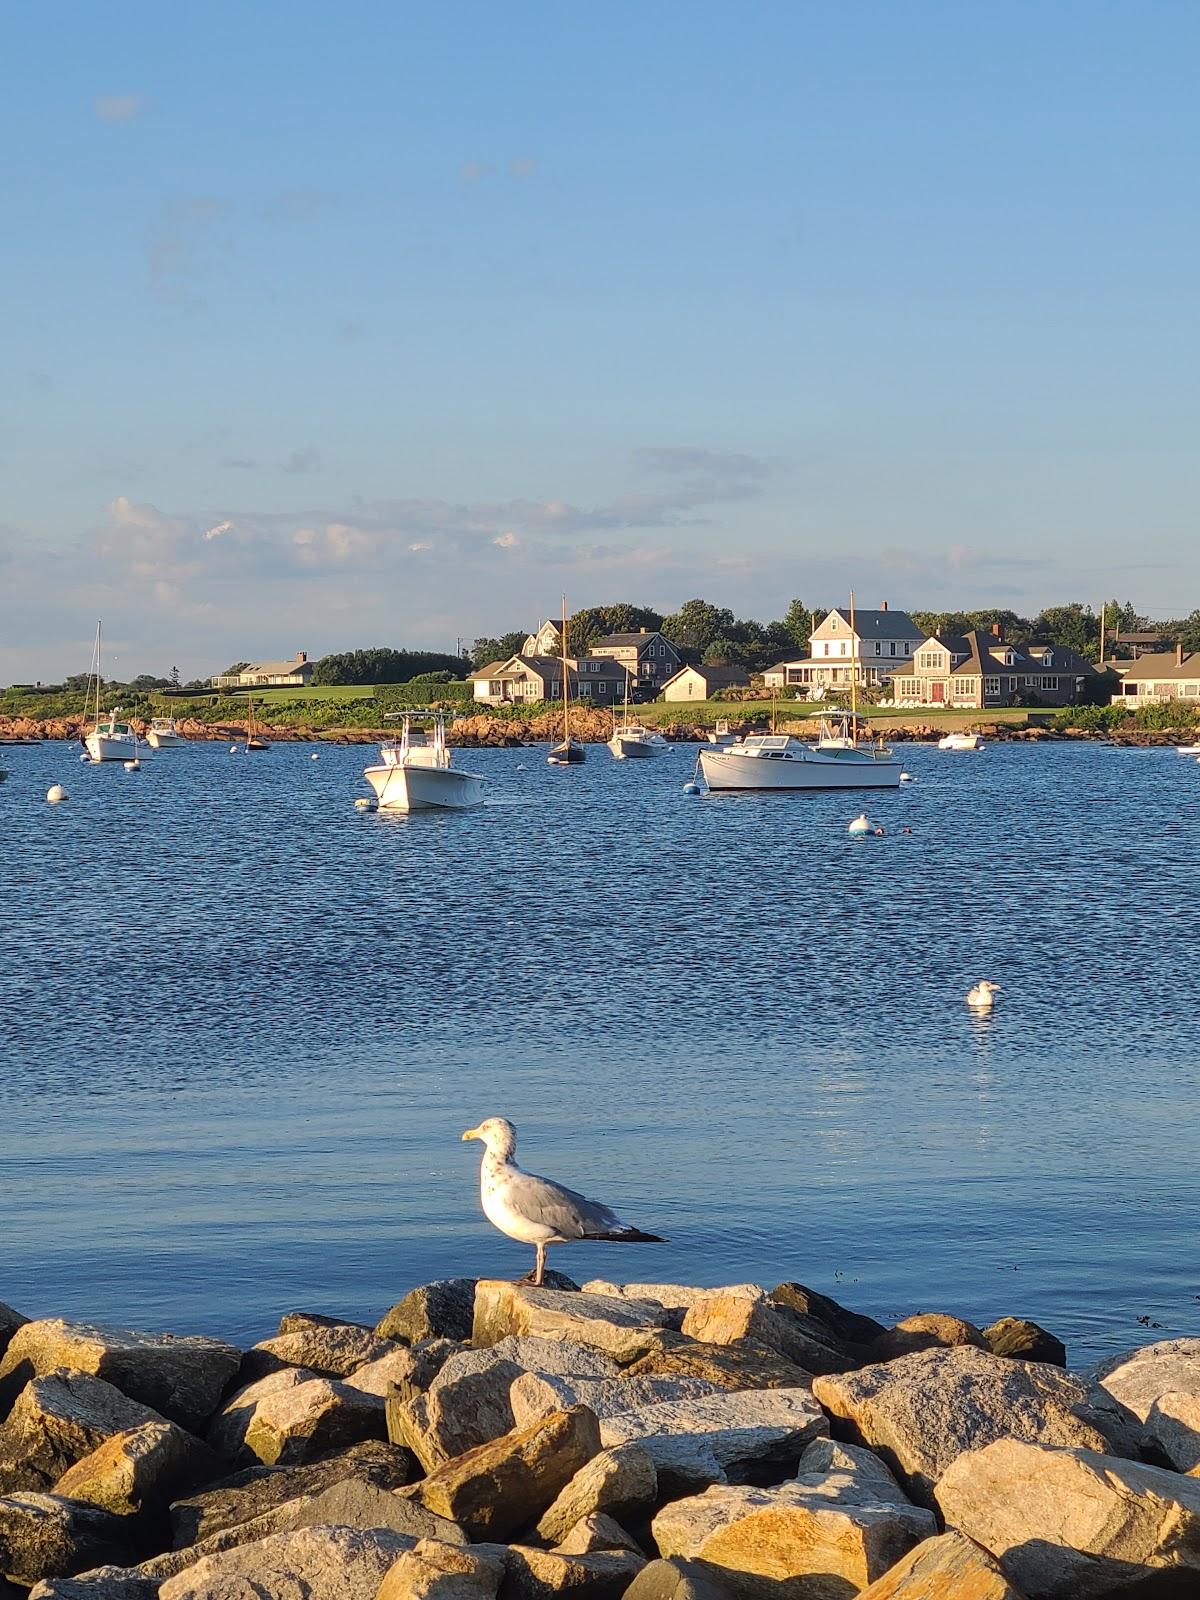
0;732;1200;1365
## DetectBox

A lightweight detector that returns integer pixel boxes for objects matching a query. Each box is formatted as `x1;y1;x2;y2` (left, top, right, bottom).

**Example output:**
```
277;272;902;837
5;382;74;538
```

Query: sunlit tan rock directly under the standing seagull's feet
470;1278;670;1362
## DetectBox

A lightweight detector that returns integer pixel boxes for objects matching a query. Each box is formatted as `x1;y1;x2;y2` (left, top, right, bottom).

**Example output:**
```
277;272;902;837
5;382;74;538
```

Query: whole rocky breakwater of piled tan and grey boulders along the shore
0;1274;1200;1600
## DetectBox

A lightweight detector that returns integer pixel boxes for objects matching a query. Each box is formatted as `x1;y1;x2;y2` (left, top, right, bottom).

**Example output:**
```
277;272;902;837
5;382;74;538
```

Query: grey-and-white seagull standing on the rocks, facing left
462;1117;666;1285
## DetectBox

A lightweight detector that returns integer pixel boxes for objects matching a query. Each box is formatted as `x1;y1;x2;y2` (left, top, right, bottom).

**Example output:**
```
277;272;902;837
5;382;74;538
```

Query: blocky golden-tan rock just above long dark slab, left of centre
208;1366;387;1467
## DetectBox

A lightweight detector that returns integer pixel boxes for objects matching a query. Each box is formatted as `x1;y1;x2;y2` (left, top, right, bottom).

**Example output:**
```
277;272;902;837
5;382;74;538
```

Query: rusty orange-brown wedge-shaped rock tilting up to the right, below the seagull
416;1406;600;1539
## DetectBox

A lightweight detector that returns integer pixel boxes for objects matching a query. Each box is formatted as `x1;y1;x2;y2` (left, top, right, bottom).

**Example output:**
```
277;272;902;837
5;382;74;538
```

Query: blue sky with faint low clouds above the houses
0;0;1200;682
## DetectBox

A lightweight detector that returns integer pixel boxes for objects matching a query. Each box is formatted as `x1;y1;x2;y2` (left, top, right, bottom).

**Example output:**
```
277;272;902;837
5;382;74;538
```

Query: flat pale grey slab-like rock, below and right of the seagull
600;1387;829;1494
